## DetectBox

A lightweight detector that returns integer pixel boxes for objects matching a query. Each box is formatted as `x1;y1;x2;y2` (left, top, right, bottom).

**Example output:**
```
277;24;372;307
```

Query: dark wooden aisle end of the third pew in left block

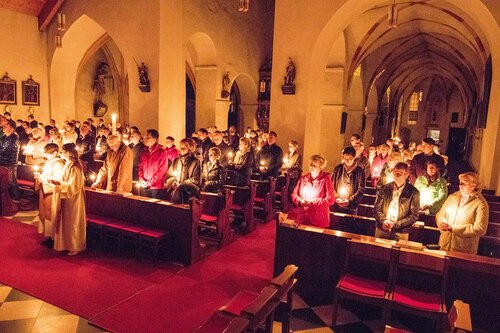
224;182;257;234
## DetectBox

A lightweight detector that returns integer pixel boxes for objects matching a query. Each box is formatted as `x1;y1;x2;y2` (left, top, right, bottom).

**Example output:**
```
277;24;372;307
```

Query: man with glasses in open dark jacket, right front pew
375;162;420;240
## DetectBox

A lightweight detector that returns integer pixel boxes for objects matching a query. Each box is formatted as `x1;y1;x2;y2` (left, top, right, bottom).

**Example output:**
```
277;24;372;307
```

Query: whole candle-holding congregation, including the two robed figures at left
0;112;488;255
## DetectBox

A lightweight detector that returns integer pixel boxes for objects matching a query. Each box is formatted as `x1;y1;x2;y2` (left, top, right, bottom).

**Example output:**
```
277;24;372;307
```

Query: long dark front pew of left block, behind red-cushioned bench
85;188;202;266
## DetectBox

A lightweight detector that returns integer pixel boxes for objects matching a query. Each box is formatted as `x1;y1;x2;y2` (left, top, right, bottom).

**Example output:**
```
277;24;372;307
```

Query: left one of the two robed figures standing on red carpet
34;143;64;247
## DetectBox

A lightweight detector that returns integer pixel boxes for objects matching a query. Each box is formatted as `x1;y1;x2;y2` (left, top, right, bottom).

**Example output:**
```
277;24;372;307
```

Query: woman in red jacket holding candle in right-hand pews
292;155;335;228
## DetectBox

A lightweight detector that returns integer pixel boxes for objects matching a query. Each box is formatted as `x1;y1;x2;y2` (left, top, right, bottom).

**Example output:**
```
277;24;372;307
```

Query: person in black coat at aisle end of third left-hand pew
227;138;254;186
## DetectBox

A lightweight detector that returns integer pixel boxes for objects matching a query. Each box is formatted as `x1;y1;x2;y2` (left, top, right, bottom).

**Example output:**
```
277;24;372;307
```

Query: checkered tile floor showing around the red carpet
0;211;425;333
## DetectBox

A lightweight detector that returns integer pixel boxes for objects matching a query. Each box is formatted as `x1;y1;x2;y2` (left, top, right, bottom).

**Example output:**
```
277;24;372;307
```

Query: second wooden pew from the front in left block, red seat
198;189;234;249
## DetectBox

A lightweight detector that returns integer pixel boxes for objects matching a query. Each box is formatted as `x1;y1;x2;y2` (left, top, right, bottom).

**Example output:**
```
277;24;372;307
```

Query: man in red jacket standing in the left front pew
137;129;167;199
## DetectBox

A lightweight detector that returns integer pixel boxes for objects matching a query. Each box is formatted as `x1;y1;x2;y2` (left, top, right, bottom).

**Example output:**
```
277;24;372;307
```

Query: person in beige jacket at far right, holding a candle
436;172;489;254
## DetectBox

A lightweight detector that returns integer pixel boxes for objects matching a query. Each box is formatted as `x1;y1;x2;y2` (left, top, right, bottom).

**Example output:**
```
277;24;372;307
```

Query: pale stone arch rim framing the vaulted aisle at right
305;0;500;188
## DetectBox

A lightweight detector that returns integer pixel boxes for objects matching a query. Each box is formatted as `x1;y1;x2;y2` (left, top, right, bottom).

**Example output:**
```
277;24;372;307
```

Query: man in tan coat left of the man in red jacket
92;135;134;193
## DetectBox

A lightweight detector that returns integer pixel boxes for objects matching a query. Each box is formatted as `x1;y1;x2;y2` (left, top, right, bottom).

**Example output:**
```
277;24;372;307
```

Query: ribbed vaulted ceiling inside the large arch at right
346;0;490;111
